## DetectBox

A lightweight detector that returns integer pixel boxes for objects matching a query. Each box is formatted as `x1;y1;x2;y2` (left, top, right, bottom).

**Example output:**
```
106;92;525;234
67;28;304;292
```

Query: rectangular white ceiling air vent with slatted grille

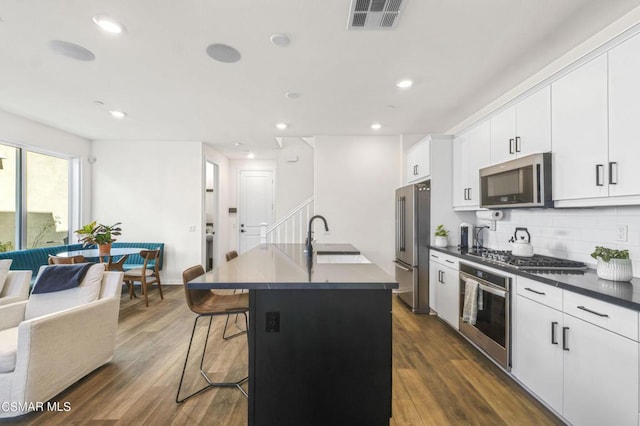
347;0;406;30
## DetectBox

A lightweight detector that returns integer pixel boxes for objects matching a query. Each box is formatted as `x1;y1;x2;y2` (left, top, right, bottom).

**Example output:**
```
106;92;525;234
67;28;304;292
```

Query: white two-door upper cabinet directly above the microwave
491;86;551;164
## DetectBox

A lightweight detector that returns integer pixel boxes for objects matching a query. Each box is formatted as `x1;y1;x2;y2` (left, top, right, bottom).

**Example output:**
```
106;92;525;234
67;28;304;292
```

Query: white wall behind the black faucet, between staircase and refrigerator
314;136;402;275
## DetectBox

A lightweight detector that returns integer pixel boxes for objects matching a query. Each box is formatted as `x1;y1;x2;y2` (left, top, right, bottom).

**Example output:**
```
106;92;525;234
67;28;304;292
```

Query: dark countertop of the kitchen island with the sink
189;244;398;290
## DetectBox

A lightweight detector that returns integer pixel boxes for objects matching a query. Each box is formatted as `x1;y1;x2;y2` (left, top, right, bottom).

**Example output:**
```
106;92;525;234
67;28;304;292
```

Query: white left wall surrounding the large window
0;111;92;229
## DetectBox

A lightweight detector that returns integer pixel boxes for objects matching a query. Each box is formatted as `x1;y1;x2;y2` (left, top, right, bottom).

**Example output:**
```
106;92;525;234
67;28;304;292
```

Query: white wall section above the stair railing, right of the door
275;138;314;220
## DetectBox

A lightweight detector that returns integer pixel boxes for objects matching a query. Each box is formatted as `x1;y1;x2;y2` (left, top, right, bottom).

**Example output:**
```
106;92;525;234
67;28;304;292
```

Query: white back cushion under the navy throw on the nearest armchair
24;263;104;320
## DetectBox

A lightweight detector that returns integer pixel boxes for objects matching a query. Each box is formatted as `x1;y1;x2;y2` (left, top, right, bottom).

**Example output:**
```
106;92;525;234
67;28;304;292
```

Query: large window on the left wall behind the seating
0;144;72;251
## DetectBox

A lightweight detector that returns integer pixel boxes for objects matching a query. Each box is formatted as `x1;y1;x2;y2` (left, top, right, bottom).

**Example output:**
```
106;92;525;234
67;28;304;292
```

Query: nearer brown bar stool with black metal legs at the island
176;265;249;403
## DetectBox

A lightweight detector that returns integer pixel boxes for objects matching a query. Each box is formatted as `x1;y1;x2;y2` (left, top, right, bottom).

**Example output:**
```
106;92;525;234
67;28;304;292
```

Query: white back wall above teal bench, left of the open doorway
91;141;205;284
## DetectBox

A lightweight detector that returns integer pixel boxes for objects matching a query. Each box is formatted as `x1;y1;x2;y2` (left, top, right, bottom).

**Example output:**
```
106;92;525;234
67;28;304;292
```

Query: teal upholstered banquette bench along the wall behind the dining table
0;242;164;282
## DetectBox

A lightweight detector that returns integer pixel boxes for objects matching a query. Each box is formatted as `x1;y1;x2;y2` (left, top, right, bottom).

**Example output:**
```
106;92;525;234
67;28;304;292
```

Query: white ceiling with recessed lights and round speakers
0;0;640;157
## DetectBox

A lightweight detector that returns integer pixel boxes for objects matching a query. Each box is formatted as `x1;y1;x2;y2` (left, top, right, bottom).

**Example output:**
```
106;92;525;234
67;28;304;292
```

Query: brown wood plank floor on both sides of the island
9;286;561;426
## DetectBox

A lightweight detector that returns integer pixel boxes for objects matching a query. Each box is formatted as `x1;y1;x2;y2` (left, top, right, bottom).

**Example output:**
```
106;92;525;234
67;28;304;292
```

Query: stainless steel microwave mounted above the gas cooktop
480;152;553;209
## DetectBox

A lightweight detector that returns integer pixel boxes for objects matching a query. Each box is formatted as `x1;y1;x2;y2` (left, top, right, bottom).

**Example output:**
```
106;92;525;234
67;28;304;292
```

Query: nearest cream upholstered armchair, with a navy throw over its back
0;264;123;418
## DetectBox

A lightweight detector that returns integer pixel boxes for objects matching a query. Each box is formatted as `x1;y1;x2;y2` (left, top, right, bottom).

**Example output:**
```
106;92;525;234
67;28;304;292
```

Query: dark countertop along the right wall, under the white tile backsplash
430;247;640;311
